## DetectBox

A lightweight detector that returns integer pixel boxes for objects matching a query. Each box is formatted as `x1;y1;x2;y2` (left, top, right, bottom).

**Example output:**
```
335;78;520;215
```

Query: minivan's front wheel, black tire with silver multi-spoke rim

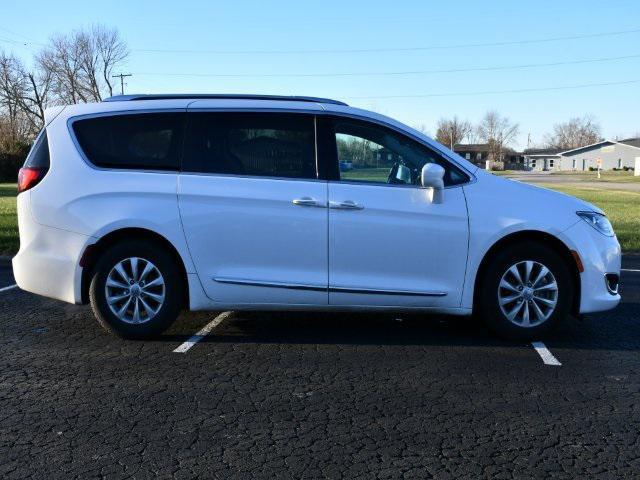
477;242;573;340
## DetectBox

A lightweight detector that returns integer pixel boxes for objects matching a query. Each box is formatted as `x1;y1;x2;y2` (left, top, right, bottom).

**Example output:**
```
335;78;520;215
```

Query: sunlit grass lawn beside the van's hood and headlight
540;183;640;253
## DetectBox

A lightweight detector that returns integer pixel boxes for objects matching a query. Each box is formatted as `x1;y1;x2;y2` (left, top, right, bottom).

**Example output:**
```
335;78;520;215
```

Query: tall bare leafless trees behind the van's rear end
0;25;129;157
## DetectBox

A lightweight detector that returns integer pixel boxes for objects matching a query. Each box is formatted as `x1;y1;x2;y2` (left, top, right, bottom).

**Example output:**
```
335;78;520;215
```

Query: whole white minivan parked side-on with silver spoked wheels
13;95;620;339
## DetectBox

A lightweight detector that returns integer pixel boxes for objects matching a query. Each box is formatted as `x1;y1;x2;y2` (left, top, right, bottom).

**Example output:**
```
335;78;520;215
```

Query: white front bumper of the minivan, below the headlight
564;221;621;313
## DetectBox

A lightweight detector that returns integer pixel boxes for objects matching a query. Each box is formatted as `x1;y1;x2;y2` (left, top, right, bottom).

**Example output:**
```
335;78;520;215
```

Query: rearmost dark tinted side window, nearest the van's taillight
73;113;185;170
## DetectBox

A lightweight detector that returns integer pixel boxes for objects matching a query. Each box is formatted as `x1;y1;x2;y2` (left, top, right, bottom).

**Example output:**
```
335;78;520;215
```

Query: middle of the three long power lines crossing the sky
136;54;640;78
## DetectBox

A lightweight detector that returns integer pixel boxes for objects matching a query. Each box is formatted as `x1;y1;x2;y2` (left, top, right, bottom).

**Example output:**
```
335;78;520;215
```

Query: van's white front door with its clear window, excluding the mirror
328;118;469;308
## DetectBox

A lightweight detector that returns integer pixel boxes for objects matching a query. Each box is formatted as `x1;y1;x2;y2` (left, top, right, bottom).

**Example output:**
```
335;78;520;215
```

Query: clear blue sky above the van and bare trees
0;0;640;147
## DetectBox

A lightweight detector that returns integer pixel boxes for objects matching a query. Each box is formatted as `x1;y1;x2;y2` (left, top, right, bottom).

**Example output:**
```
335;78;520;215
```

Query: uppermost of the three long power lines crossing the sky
131;28;640;55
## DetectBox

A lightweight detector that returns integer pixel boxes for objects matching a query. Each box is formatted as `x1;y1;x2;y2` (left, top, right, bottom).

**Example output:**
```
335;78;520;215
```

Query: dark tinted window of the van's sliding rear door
183;113;316;178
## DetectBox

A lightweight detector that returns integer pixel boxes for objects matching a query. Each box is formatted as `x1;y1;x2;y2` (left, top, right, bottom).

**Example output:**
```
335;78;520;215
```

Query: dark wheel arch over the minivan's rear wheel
80;227;189;305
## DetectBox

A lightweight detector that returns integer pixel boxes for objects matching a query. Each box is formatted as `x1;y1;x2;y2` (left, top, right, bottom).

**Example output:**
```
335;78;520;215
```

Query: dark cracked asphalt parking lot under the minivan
0;257;640;479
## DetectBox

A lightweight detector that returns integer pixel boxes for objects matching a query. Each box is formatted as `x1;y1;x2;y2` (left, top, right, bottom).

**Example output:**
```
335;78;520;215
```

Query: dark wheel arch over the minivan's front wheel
473;230;581;315
